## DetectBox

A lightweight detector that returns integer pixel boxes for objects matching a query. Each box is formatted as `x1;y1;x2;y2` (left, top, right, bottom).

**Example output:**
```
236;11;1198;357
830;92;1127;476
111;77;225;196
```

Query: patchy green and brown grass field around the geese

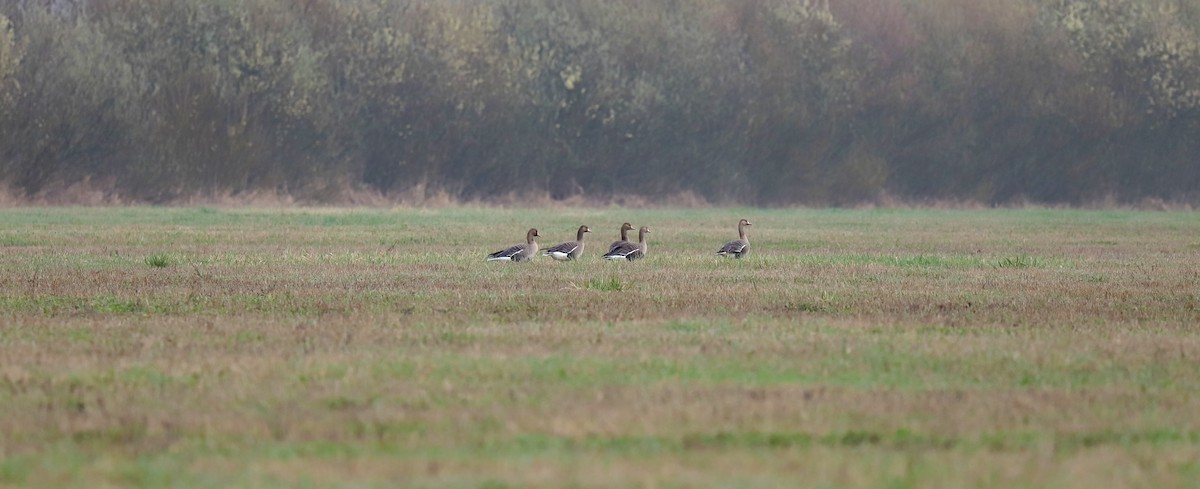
0;204;1200;488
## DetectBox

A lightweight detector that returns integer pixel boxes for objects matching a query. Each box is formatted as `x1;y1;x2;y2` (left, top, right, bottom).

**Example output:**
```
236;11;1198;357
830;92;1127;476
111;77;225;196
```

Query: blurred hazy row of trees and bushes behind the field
0;0;1200;205
